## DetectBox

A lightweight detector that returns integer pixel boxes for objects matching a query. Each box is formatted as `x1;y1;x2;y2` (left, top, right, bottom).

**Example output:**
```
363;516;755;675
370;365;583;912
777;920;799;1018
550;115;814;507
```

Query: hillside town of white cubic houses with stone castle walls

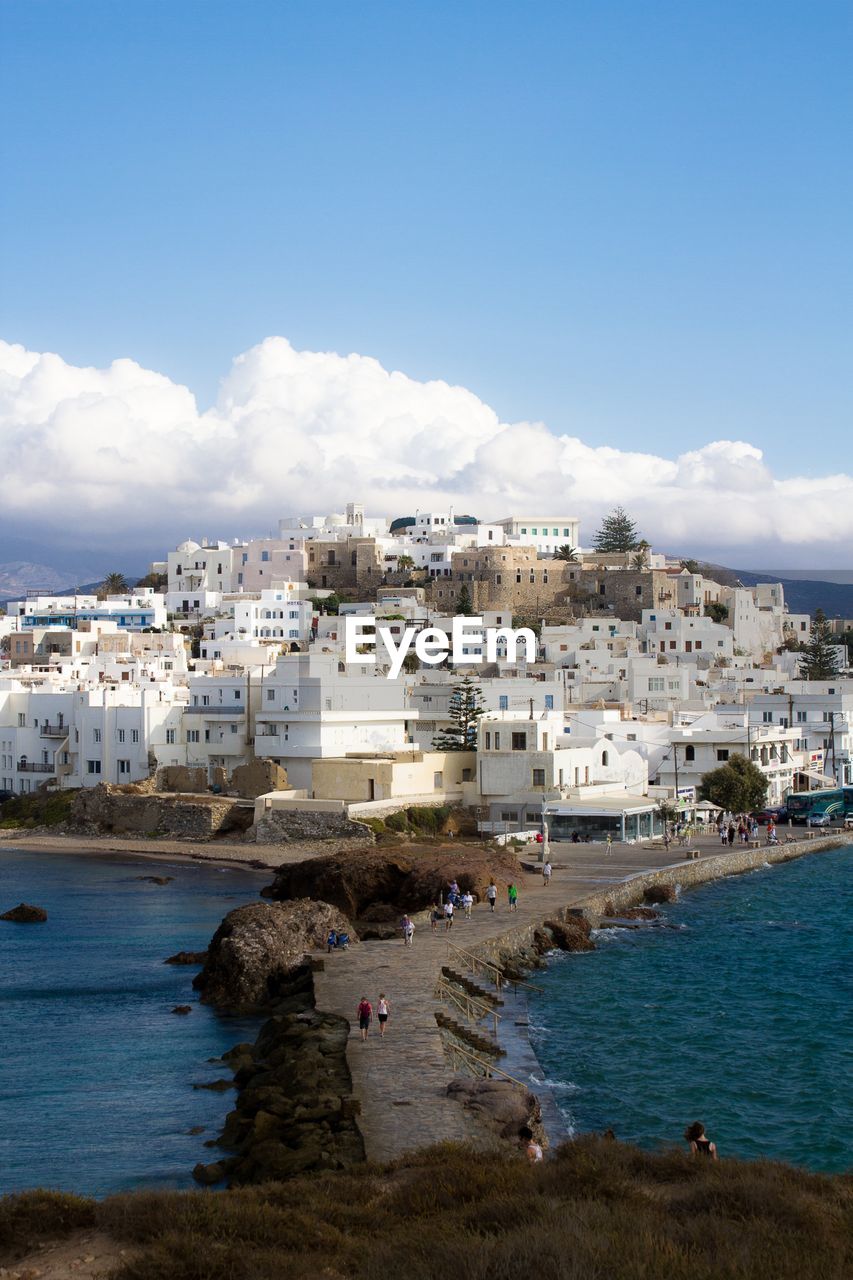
0;503;853;841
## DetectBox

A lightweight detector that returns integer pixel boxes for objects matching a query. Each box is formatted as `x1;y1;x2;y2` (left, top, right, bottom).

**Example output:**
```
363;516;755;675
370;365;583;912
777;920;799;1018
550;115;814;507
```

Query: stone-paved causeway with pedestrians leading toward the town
315;837;722;1161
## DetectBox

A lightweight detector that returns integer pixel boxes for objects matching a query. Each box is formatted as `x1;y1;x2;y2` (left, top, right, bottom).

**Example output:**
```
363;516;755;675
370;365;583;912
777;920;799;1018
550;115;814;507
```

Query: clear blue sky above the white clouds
0;0;853;561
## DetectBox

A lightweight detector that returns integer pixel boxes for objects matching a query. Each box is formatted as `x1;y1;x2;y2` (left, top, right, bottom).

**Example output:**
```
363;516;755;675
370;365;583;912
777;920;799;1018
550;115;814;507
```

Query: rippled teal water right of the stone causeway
530;845;853;1171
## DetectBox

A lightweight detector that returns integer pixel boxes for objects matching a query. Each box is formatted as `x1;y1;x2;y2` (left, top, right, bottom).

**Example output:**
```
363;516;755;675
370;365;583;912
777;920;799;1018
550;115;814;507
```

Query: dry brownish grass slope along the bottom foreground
0;1137;853;1280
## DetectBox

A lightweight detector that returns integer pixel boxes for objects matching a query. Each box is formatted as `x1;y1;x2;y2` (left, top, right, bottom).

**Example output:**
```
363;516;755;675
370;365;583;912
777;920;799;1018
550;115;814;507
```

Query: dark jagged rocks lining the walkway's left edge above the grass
193;966;365;1185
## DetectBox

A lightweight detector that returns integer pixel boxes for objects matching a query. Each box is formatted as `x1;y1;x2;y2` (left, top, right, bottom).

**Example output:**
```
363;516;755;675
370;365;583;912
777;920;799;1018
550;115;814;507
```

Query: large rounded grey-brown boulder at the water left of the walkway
192;899;357;1012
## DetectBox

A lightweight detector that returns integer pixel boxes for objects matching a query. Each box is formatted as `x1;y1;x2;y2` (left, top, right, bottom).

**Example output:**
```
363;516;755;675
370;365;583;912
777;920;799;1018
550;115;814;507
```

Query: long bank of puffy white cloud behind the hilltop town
0;338;853;558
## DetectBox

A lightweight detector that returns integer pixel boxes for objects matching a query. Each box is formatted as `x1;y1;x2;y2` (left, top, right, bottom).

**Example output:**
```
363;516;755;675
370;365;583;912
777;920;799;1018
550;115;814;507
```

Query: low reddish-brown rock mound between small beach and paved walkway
261;845;520;920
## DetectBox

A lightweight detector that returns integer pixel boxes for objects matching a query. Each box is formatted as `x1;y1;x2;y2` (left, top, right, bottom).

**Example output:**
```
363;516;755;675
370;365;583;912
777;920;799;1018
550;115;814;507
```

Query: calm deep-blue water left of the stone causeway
0;847;263;1196
